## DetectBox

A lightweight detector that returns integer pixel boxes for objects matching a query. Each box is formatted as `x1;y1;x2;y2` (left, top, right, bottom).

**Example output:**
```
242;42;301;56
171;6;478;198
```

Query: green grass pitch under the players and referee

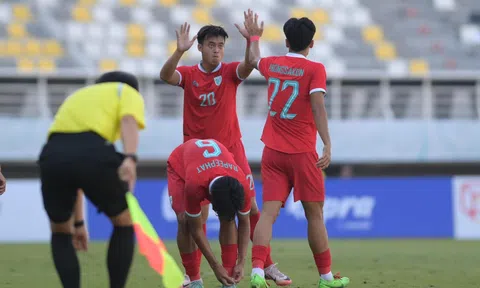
0;240;480;288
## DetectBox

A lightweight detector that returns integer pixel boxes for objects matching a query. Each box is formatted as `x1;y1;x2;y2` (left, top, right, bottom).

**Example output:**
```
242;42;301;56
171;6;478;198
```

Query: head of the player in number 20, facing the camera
197;25;228;66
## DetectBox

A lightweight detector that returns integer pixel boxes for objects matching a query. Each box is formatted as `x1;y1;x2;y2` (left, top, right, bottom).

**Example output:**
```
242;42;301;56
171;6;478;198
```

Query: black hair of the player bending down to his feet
210;176;245;221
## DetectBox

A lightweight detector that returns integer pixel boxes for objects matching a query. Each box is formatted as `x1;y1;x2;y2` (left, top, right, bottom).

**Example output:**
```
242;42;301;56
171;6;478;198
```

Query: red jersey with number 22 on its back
257;53;327;154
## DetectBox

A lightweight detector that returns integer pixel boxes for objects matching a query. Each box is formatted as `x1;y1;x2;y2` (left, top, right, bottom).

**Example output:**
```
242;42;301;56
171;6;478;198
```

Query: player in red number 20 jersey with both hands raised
160;10;292;286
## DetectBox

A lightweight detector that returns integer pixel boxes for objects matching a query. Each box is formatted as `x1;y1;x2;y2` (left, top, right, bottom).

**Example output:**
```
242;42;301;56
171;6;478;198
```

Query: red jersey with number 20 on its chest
177;62;243;147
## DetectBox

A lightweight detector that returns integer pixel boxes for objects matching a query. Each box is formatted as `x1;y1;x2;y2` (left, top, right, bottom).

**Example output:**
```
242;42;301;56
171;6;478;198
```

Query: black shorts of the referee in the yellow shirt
38;132;128;223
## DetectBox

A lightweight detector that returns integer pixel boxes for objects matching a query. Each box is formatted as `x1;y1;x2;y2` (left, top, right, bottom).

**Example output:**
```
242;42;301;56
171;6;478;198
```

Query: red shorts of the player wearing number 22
261;146;325;204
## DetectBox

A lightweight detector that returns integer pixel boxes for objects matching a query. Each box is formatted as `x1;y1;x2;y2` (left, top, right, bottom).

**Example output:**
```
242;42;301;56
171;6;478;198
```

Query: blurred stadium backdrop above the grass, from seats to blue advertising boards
0;0;480;270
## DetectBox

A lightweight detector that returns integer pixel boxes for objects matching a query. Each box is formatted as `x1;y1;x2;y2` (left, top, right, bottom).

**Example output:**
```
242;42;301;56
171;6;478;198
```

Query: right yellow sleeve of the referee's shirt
118;83;145;129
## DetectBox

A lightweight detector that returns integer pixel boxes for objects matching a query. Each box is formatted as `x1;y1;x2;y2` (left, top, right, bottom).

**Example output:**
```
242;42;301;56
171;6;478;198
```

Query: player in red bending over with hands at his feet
167;139;251;288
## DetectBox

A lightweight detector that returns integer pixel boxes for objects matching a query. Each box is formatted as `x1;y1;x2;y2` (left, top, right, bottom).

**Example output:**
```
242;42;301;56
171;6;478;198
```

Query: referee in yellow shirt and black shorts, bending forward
38;71;145;288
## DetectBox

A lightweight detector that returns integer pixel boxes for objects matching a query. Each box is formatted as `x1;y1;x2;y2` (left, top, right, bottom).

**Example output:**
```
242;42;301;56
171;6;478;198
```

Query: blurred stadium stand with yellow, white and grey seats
0;0;480;119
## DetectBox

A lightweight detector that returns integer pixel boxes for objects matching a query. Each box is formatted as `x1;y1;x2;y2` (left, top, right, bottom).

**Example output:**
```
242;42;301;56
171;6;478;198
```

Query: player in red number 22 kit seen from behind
245;15;350;288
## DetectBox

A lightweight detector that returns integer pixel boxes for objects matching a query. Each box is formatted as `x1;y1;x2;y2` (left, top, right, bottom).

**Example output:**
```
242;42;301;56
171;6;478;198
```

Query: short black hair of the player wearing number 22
283;17;316;52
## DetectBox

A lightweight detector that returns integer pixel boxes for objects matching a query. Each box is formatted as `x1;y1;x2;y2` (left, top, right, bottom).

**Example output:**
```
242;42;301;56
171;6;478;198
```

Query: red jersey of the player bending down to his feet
168;139;251;217
